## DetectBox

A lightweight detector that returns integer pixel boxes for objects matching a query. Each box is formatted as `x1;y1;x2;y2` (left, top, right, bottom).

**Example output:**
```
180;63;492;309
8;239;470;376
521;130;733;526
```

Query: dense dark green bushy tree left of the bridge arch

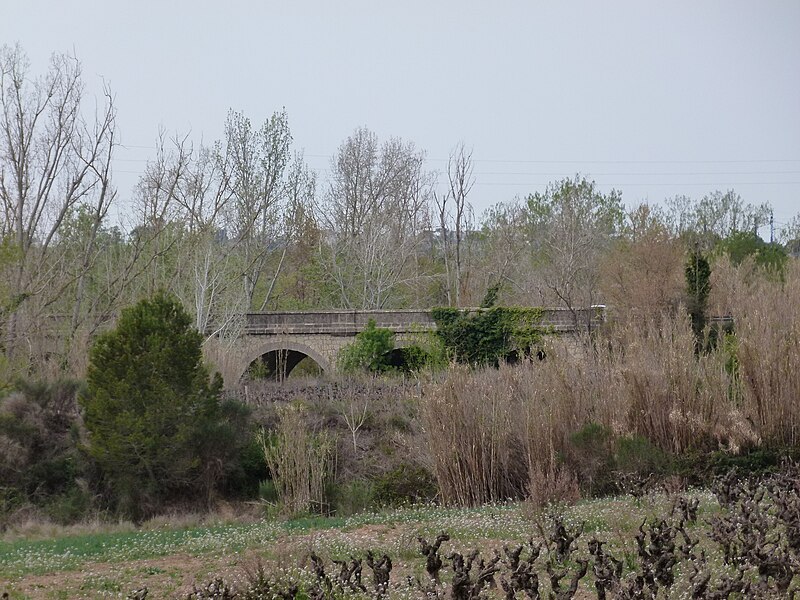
81;292;233;518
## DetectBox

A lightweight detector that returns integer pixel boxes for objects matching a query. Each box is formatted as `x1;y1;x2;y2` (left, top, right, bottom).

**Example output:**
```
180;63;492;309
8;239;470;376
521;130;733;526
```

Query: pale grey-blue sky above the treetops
0;0;800;236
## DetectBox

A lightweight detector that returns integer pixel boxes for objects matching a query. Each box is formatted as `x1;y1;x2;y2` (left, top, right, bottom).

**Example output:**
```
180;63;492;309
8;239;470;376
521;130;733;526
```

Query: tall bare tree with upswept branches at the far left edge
0;46;115;368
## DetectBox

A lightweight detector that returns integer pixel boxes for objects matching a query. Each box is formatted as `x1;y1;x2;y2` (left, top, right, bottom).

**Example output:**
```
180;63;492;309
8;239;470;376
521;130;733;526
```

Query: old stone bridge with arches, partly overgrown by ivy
218;306;605;385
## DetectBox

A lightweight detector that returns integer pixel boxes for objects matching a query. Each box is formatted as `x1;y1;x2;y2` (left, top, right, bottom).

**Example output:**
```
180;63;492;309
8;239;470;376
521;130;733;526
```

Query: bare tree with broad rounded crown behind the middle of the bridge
320;129;431;308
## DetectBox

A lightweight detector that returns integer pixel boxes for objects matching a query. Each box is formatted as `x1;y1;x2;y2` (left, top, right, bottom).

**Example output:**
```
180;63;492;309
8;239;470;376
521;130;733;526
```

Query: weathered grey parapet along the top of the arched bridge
244;306;605;336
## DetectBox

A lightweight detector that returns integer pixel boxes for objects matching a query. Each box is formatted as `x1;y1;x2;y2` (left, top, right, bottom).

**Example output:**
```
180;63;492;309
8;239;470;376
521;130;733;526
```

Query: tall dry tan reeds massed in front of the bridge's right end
422;264;800;505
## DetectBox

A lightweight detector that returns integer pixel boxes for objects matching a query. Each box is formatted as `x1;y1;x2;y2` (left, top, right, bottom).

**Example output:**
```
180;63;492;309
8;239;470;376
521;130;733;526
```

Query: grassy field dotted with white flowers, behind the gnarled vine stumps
0;493;719;599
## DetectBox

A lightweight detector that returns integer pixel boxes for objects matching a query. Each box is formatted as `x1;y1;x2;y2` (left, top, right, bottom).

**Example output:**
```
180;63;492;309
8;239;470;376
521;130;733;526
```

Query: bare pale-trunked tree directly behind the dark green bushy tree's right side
132;132;248;340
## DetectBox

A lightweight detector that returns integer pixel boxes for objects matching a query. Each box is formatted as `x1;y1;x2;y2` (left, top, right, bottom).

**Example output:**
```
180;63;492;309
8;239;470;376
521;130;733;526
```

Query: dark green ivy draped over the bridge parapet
431;307;547;365
